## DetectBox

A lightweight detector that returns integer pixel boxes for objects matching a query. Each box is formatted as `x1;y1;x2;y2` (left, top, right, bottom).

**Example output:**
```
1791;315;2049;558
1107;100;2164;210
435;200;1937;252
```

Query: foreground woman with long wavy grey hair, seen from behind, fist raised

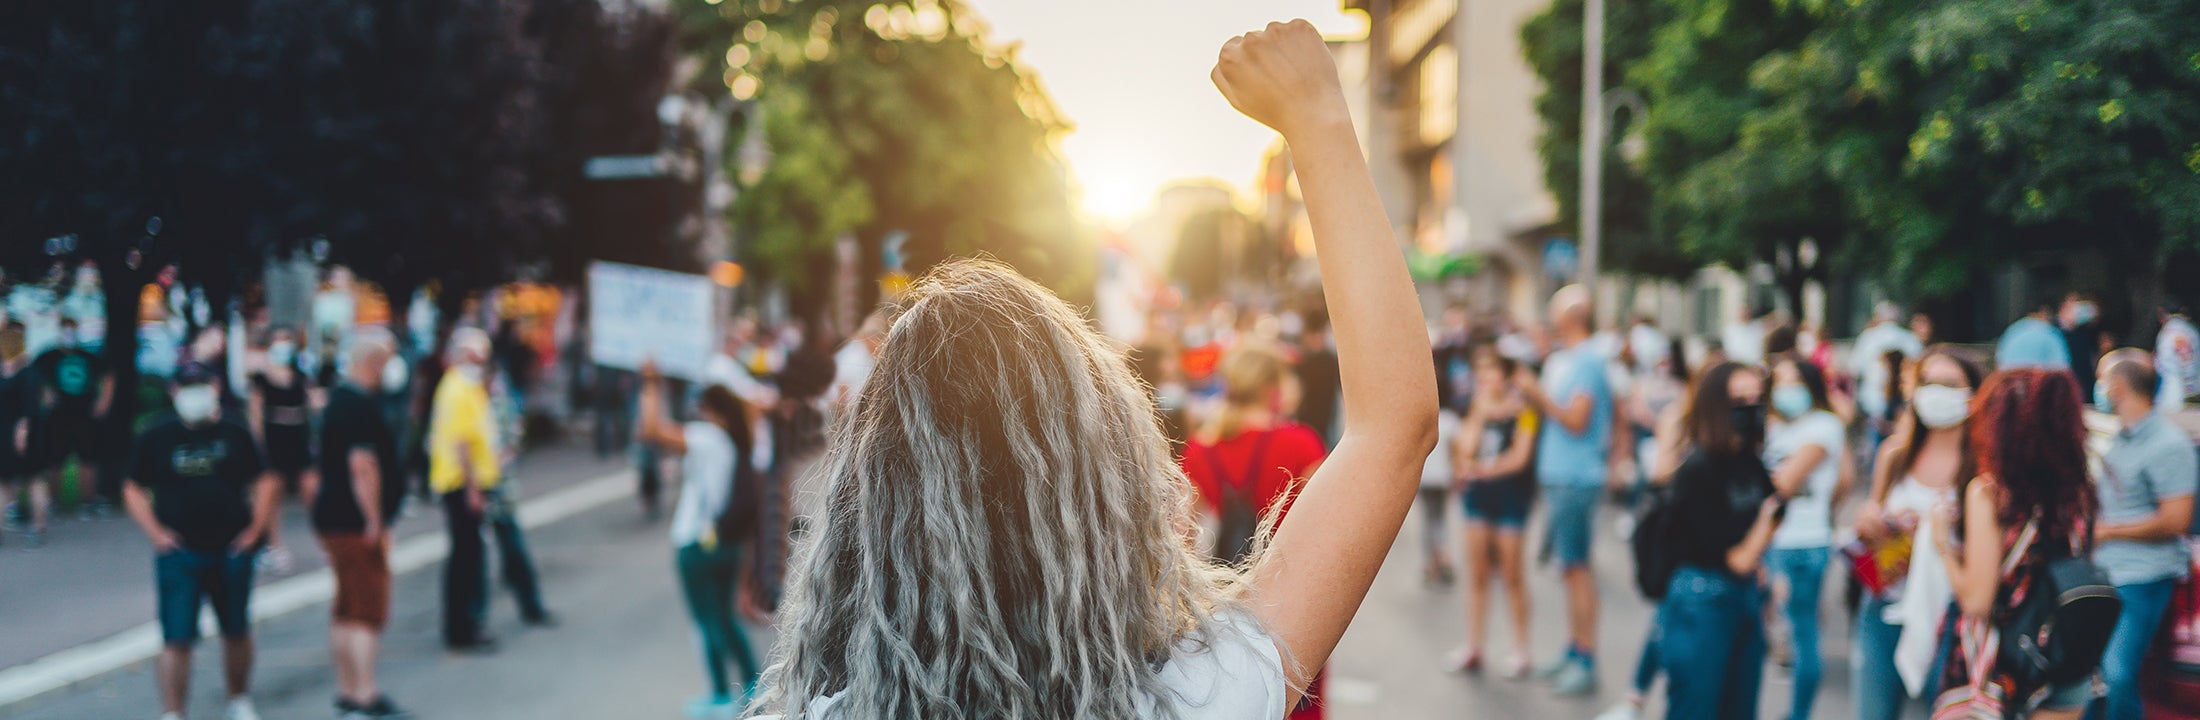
752;22;1437;720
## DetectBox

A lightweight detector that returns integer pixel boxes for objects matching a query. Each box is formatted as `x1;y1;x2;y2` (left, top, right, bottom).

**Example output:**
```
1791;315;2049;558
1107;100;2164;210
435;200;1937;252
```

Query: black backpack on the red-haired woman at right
1995;528;2123;694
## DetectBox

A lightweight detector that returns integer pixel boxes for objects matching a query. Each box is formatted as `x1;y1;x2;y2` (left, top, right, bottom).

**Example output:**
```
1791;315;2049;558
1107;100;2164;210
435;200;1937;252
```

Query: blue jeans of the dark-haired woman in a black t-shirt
1657;566;1764;720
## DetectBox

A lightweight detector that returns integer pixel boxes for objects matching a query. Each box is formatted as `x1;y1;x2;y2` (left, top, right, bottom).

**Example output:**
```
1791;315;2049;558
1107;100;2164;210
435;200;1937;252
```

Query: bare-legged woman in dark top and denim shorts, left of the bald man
1437;346;1538;678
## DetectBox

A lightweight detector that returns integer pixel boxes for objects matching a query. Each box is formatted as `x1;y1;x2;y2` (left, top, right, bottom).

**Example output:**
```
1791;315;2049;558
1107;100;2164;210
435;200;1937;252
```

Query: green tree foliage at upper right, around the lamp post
1525;0;2200;297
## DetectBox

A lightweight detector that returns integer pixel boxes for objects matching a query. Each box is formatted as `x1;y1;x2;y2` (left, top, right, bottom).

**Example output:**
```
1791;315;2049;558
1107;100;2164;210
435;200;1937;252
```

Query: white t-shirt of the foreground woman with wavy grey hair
759;612;1287;720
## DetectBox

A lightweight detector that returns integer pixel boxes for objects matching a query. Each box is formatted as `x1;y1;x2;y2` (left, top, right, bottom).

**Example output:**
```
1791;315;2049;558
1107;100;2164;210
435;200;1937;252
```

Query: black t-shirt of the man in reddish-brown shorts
312;385;405;533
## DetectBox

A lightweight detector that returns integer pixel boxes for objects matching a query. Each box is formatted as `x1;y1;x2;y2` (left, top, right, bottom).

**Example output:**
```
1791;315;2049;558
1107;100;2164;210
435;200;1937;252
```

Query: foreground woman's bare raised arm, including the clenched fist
1214;20;1437;702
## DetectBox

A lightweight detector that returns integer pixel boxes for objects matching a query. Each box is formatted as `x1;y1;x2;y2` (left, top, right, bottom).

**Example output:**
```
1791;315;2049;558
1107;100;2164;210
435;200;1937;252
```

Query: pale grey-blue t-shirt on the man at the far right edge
2092;414;2200;586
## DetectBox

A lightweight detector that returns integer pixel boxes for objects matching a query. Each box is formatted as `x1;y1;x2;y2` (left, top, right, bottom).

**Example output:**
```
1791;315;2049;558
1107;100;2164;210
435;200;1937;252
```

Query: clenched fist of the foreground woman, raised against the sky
1214;20;1351;139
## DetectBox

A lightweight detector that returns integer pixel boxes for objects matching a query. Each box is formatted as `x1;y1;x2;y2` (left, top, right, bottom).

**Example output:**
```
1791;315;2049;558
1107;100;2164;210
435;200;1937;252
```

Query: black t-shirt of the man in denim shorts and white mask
130;418;266;550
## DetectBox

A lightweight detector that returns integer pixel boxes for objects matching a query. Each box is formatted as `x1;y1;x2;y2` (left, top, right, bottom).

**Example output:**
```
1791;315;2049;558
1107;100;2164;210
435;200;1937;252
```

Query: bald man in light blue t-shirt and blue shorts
1514;286;1615;696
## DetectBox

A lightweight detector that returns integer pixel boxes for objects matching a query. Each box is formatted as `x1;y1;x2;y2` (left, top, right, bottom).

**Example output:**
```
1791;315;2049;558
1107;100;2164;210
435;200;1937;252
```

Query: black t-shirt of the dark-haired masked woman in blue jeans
1670;451;1773;575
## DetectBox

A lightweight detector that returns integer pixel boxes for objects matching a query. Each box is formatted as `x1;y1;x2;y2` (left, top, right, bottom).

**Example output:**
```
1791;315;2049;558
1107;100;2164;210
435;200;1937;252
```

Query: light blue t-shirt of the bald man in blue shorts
1536;346;1613;487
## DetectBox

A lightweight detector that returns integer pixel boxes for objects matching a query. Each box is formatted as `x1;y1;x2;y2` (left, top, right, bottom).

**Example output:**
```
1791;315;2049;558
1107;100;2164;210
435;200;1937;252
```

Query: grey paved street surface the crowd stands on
0;462;1892;720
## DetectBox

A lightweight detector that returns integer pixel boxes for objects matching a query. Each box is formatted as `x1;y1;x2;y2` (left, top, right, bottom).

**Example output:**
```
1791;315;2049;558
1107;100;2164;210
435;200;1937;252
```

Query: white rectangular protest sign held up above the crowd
587;262;717;381
